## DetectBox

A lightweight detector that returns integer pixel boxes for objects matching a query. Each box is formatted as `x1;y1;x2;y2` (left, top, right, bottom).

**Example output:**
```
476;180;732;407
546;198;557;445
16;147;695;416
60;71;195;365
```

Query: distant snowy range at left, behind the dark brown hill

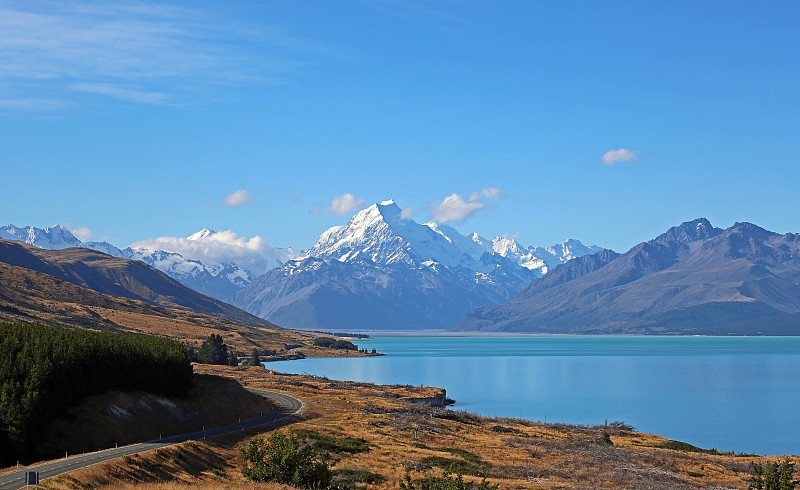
0;225;299;301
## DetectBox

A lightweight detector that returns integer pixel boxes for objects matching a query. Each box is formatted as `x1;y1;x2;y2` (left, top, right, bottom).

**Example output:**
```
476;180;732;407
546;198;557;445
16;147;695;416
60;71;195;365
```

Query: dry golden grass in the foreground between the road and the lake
36;365;792;489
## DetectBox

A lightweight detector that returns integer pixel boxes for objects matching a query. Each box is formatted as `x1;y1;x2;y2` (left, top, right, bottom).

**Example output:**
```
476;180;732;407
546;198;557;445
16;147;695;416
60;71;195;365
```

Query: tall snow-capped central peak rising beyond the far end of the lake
231;201;596;329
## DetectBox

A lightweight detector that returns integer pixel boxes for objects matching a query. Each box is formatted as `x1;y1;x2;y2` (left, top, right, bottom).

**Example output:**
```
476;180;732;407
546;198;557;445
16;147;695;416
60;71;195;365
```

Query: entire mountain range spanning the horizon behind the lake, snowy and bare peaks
10;209;800;335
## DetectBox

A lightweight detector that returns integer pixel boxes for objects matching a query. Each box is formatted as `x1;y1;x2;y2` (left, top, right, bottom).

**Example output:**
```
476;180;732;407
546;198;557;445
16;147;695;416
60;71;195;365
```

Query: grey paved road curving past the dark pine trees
0;388;303;490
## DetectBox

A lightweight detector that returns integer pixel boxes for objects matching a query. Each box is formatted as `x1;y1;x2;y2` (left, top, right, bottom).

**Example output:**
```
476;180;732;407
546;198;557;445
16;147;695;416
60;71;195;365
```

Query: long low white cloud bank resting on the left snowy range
131;230;298;275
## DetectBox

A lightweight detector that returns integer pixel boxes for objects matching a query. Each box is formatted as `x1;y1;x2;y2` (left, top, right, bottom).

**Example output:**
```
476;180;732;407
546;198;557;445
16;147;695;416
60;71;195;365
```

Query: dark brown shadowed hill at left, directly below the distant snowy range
0;239;279;329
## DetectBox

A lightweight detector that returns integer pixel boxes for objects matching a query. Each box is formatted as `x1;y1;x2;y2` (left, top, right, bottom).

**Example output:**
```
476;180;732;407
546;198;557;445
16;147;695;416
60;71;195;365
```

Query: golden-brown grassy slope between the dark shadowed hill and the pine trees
0;262;312;354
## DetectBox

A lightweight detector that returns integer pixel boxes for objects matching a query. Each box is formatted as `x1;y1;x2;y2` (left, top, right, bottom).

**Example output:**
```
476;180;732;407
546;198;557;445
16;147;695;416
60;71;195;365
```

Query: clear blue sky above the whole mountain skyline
0;0;800;251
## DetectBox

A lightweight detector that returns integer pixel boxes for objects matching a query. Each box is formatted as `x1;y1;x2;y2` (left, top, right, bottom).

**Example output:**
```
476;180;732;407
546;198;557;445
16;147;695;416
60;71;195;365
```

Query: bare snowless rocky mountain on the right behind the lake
453;219;800;334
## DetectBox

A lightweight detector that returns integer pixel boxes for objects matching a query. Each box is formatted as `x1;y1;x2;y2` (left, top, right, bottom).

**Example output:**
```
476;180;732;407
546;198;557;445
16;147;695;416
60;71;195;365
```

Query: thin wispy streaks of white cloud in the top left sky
0;0;338;110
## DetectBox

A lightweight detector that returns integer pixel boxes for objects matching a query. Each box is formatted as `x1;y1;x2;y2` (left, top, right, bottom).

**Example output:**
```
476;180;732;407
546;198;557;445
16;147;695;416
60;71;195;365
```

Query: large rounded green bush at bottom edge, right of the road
240;432;332;490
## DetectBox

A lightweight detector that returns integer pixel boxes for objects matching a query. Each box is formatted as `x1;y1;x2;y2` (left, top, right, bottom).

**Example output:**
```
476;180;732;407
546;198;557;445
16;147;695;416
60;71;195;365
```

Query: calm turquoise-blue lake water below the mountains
266;337;800;455
